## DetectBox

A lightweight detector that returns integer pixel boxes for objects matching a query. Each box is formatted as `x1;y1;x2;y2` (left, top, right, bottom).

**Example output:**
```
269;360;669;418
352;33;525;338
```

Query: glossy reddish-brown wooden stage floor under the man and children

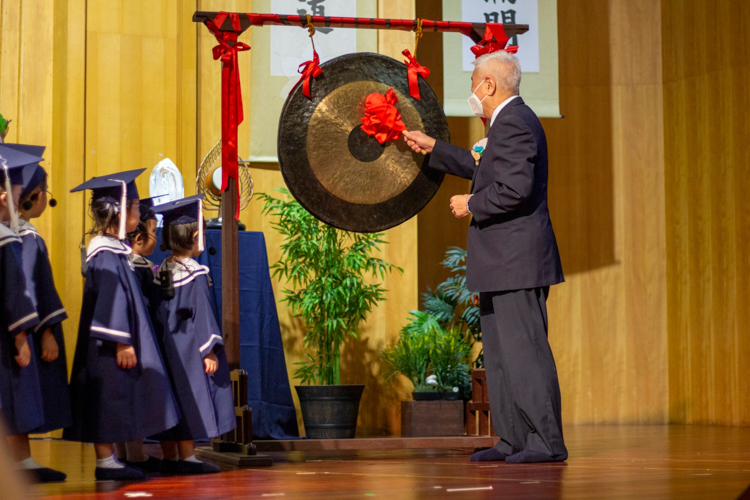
25;426;750;500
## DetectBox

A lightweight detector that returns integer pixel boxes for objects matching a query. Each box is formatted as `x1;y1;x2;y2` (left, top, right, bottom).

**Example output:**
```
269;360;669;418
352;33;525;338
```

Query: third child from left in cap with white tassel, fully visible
63;169;179;480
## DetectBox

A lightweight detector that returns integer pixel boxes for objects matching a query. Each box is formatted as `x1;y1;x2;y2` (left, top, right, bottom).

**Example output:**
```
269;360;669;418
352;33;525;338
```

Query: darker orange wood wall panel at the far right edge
662;0;750;425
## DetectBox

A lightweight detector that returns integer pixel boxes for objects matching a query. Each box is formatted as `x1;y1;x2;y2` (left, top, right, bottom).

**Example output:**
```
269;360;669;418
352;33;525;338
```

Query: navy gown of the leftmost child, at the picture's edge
0;224;44;436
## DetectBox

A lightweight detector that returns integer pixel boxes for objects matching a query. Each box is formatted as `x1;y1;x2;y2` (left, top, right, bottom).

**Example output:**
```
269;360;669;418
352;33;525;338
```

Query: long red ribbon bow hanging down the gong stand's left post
206;12;250;220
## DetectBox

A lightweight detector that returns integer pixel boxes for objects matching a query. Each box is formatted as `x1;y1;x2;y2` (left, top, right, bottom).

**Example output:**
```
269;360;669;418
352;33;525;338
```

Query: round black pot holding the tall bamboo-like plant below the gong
294;385;365;439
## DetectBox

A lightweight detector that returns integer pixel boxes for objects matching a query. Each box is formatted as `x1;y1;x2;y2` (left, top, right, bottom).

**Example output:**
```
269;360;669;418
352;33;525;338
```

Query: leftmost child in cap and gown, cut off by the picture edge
0;144;66;482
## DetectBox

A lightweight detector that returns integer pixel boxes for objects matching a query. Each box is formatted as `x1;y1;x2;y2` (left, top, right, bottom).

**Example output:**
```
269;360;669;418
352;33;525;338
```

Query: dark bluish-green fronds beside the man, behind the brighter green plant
424;247;484;368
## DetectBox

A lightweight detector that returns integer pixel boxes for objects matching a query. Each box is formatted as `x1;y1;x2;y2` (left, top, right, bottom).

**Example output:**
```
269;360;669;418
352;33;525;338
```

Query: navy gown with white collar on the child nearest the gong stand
155;259;236;441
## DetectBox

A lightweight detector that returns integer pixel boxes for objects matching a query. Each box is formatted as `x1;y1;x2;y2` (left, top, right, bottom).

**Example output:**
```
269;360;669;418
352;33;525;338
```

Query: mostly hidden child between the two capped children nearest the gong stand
115;198;161;472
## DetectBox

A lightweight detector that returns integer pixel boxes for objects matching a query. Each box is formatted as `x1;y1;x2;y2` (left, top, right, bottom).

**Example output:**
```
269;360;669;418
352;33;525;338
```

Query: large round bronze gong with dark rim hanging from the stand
278;53;450;233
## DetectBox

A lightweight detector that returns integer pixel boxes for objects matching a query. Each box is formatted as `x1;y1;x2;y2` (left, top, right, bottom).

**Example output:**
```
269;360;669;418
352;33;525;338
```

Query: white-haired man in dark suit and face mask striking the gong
404;51;568;463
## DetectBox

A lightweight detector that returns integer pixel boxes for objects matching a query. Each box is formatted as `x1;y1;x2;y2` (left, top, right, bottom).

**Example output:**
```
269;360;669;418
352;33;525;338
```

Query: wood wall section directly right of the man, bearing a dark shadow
540;0;668;424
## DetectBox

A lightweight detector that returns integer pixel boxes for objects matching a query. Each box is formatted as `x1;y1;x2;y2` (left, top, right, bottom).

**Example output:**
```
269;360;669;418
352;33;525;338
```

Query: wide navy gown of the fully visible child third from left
63;236;179;443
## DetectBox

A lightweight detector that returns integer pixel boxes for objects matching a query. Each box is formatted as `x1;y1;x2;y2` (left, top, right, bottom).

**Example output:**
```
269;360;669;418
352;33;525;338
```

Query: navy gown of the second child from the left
18;220;73;433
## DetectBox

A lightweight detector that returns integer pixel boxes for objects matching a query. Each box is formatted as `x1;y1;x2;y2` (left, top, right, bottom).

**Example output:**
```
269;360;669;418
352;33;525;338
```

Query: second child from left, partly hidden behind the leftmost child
18;163;73;434
